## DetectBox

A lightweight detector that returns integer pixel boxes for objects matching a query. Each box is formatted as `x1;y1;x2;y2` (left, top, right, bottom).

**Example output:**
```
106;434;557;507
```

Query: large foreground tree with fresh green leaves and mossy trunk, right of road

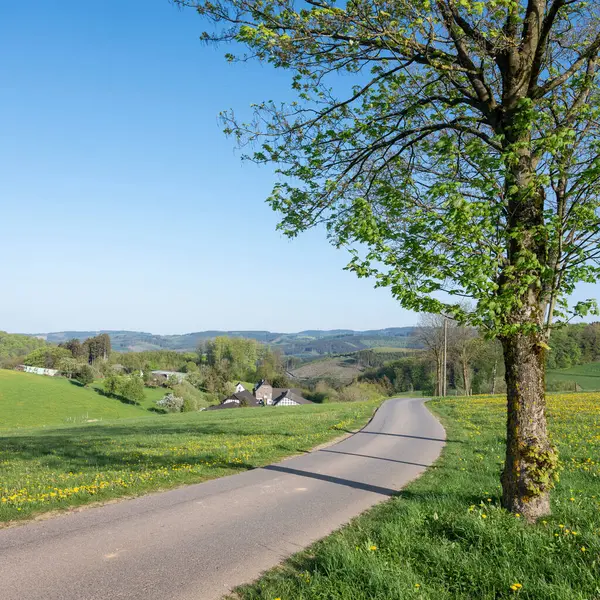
182;0;600;520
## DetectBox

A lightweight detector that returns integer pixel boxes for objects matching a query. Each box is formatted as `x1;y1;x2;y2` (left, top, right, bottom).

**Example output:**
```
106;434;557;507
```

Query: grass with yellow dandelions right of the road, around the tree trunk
234;394;600;600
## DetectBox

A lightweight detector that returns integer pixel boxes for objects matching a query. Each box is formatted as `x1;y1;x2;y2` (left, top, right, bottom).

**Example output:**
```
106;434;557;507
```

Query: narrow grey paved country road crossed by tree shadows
0;399;445;600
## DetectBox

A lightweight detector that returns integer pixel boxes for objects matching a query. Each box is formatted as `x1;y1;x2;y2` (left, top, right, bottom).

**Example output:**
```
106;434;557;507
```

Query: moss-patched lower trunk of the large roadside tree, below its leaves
502;334;557;522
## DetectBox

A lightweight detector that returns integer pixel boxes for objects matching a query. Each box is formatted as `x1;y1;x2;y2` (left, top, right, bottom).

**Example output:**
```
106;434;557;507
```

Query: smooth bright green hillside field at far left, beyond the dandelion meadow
0;370;148;430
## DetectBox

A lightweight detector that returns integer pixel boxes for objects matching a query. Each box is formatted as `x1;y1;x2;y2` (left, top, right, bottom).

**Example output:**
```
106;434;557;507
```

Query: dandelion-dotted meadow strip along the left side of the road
0;402;379;521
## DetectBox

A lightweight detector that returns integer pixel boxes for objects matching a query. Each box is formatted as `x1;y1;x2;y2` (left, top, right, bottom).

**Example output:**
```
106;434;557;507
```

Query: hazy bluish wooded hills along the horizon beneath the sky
24;327;419;357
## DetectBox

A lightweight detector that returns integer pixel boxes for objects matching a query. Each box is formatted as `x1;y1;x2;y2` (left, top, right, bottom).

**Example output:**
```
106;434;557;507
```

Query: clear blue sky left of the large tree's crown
0;0;594;333
